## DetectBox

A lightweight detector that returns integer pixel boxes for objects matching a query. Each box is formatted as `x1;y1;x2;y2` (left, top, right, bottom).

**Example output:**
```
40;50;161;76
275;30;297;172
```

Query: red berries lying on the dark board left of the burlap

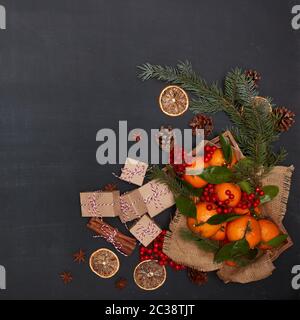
140;230;186;271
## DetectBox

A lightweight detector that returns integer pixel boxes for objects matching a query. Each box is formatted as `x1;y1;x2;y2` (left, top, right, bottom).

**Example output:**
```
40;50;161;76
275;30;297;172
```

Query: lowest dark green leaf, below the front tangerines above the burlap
215;239;250;263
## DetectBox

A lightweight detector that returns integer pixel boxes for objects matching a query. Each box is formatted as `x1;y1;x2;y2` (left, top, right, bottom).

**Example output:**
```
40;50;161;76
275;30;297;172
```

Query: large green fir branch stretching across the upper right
138;61;286;180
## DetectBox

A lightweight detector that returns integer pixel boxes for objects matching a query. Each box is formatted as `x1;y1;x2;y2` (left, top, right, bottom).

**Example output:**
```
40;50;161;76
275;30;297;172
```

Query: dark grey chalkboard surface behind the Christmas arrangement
0;0;300;299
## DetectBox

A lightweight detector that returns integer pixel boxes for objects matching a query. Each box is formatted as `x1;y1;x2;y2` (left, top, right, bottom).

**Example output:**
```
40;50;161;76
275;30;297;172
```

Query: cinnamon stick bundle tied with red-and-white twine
87;218;136;256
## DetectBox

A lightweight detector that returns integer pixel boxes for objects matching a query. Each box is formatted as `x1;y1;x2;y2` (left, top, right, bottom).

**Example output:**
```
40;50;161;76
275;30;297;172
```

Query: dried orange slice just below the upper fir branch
159;86;189;117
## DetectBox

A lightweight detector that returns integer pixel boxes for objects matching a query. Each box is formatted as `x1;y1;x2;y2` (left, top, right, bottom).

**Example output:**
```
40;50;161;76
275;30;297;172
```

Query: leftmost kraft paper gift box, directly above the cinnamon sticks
80;191;120;217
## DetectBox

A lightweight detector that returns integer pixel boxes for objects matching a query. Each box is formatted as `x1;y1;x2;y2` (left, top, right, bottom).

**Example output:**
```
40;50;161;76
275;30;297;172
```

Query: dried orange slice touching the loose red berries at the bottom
133;260;167;291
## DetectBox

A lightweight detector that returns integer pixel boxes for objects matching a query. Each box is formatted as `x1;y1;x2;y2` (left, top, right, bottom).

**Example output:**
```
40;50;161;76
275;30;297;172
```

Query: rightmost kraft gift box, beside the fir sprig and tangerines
139;180;175;218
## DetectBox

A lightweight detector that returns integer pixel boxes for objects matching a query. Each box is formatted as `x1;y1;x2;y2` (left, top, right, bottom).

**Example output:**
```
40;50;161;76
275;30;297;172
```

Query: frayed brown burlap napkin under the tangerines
163;166;294;283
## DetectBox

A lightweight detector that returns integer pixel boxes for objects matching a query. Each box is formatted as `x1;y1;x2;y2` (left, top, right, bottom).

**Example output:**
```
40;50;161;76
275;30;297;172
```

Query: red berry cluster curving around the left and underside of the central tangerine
200;183;234;214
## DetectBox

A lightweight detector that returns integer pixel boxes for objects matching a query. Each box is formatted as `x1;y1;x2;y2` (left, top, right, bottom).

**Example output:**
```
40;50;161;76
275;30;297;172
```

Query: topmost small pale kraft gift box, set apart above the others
120;158;148;186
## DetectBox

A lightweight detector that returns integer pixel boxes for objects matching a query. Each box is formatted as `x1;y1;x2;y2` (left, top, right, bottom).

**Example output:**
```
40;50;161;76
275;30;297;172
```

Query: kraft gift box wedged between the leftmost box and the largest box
120;189;147;223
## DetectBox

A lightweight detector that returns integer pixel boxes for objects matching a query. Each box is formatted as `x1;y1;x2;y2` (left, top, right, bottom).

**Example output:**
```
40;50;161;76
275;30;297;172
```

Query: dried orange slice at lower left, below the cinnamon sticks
90;248;120;278
